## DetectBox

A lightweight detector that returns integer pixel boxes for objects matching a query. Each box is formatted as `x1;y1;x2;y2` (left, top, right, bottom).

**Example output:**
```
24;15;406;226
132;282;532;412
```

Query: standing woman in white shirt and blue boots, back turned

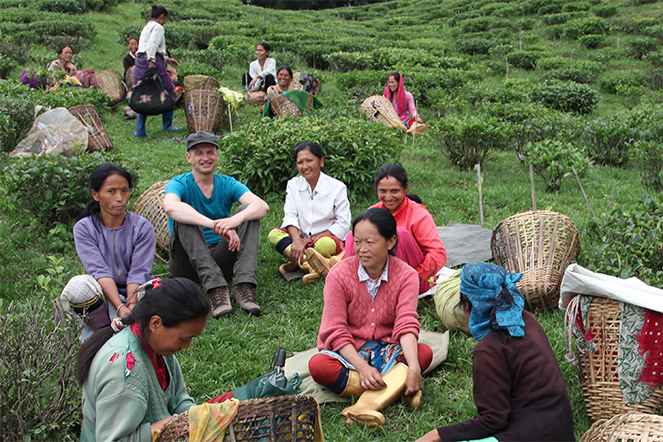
134;5;181;137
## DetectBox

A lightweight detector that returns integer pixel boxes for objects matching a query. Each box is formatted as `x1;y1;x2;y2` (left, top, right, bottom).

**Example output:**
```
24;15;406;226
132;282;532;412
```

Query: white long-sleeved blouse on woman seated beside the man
281;172;351;241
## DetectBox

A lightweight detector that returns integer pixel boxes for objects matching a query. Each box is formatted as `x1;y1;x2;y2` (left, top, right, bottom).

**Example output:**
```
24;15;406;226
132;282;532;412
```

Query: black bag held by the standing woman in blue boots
127;67;177;115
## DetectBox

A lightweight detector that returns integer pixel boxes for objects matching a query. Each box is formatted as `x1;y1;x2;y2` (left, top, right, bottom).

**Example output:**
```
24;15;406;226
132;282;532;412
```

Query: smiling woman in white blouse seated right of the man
267;141;351;283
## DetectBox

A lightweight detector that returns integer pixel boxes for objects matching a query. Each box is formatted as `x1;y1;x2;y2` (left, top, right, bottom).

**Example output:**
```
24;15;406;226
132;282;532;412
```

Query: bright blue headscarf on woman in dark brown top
460;262;525;341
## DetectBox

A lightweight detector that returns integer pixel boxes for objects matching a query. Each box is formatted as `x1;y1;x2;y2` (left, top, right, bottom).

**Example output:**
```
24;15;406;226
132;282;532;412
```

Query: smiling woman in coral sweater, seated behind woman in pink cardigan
346;163;447;293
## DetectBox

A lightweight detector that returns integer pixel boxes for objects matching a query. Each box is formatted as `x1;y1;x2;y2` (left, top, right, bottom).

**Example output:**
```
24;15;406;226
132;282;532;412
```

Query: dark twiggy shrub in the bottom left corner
0;296;81;441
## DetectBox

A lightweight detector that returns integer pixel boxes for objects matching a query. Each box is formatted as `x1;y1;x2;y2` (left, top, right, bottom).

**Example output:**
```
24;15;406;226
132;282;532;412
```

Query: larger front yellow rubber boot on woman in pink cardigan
341;362;409;428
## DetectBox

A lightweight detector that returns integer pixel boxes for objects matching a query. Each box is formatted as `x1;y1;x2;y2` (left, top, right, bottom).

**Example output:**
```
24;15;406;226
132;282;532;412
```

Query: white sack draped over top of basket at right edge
559;264;663;313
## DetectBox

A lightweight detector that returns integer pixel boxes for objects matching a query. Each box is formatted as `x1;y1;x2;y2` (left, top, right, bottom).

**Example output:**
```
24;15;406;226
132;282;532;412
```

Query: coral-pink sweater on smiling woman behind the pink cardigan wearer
371;197;447;281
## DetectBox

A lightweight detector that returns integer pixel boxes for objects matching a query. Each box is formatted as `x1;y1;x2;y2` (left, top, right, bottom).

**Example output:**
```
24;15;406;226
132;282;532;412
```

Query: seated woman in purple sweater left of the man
61;163;156;341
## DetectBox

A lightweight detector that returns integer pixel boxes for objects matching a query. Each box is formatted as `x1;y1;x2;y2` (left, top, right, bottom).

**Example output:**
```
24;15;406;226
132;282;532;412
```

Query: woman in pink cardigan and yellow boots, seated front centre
309;208;433;427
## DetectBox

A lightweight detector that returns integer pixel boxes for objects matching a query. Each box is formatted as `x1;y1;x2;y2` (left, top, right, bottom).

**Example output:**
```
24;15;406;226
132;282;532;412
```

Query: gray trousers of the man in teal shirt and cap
170;204;260;291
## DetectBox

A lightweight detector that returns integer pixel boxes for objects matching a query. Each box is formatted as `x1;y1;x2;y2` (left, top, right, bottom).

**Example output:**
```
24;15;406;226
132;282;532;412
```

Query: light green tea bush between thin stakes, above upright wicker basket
524;139;590;193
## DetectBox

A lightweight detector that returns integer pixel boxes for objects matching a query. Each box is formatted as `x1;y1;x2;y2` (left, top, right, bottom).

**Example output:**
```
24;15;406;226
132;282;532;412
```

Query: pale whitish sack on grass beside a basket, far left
9;106;88;157
